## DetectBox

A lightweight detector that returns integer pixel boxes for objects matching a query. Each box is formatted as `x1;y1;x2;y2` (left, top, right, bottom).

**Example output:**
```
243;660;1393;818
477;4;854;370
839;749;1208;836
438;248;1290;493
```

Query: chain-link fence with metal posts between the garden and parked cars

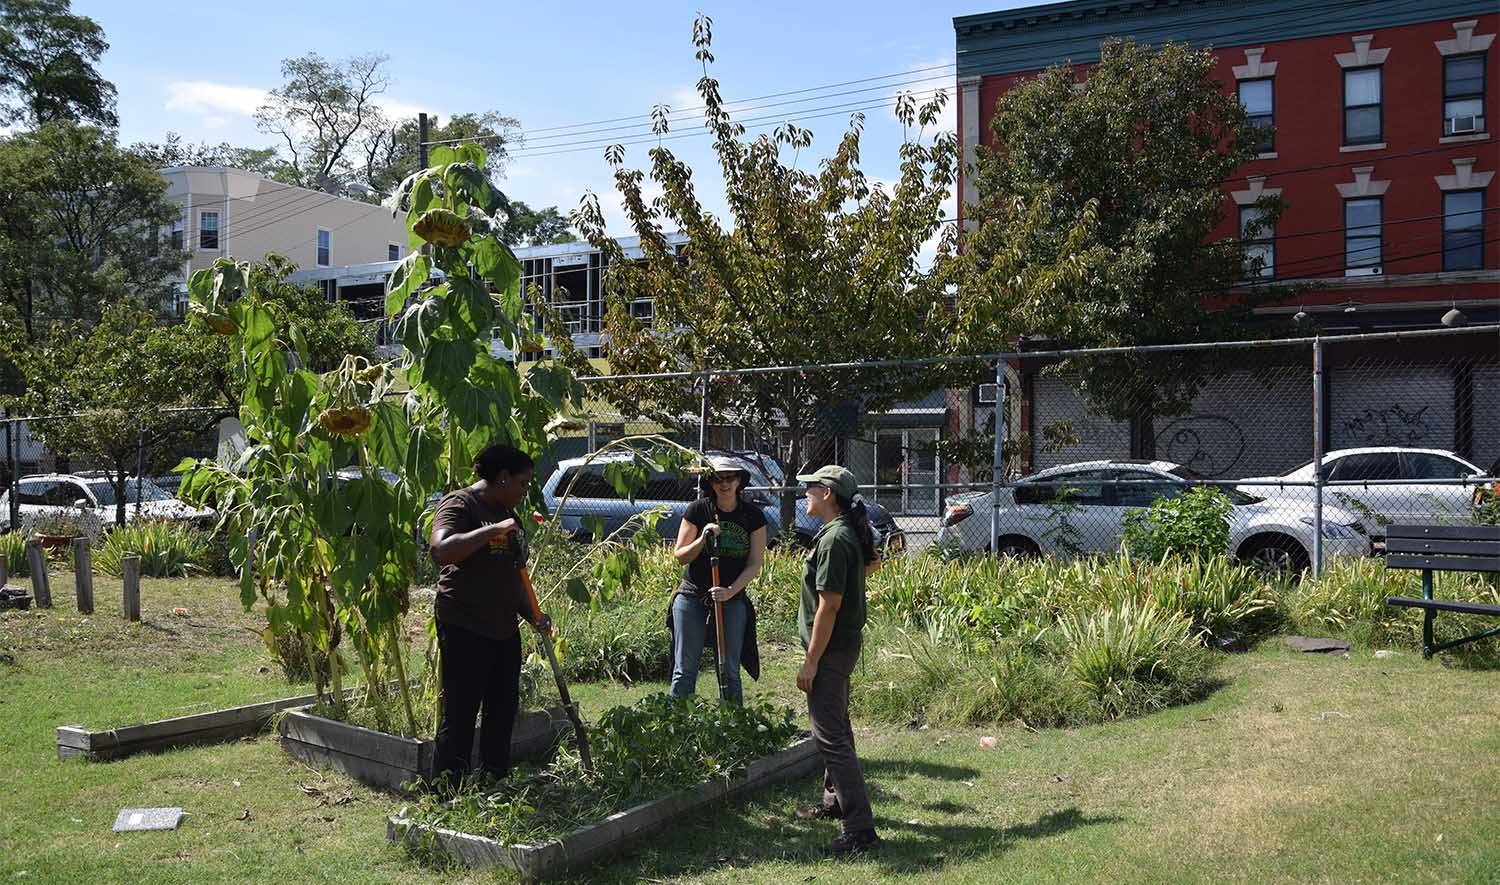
0;327;1500;570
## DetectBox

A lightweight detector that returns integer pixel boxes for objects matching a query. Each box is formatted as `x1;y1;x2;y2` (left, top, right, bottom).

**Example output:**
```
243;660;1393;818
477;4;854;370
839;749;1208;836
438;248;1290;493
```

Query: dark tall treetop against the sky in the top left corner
0;0;116;126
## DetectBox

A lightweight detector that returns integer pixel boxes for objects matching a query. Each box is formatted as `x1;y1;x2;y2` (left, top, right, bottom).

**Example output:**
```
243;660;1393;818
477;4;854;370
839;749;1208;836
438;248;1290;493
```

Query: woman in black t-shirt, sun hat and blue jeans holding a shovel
669;458;765;704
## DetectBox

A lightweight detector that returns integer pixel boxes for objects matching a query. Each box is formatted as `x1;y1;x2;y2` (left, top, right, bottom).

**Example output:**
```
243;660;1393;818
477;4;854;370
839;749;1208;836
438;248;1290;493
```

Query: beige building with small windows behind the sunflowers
161;167;407;309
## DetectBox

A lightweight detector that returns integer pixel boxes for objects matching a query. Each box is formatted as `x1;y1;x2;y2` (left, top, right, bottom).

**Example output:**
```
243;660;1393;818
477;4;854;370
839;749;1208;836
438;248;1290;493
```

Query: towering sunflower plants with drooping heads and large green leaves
179;146;582;734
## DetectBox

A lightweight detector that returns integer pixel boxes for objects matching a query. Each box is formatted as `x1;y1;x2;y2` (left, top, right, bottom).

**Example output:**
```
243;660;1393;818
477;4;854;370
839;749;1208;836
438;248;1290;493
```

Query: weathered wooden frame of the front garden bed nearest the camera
386;738;821;882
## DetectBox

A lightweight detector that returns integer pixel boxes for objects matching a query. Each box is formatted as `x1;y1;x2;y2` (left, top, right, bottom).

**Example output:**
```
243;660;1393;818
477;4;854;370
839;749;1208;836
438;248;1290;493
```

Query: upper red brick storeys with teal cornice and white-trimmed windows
954;0;1500;333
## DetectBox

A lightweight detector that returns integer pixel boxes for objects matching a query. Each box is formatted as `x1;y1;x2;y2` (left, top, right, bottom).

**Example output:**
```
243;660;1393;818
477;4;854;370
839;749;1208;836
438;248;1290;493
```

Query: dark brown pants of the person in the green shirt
807;645;875;833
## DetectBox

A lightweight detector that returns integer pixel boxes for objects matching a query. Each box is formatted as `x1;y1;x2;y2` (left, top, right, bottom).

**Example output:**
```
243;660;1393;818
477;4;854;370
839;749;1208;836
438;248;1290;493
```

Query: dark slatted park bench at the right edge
1386;525;1500;657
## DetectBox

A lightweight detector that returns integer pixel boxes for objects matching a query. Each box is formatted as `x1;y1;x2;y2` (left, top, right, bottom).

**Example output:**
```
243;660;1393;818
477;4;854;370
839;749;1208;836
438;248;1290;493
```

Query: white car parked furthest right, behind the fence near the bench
1238;446;1485;537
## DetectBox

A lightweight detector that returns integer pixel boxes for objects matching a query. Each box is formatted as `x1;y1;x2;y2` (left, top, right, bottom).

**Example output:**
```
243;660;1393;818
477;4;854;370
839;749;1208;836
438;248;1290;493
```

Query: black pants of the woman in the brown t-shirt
434;623;521;779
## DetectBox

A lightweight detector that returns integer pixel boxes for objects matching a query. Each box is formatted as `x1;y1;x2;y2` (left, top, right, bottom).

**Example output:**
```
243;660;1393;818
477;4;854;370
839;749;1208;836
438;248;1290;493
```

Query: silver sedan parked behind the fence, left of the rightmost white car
938;461;1370;572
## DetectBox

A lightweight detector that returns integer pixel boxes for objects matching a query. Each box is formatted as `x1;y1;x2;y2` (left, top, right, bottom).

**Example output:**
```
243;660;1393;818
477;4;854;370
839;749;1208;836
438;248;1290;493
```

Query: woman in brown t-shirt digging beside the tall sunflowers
429;444;552;783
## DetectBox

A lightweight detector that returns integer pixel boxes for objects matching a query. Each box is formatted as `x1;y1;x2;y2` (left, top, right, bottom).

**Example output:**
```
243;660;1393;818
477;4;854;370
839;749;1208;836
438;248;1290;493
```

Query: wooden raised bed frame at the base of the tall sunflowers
278;707;570;792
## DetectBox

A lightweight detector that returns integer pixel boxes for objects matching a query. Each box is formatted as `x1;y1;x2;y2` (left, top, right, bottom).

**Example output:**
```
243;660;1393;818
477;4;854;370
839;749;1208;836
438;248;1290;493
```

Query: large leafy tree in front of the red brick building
954;42;1286;458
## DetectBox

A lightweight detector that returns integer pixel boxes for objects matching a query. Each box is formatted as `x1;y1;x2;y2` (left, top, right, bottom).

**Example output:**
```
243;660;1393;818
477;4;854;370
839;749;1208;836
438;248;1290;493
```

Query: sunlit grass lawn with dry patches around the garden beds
0;575;1500;885
